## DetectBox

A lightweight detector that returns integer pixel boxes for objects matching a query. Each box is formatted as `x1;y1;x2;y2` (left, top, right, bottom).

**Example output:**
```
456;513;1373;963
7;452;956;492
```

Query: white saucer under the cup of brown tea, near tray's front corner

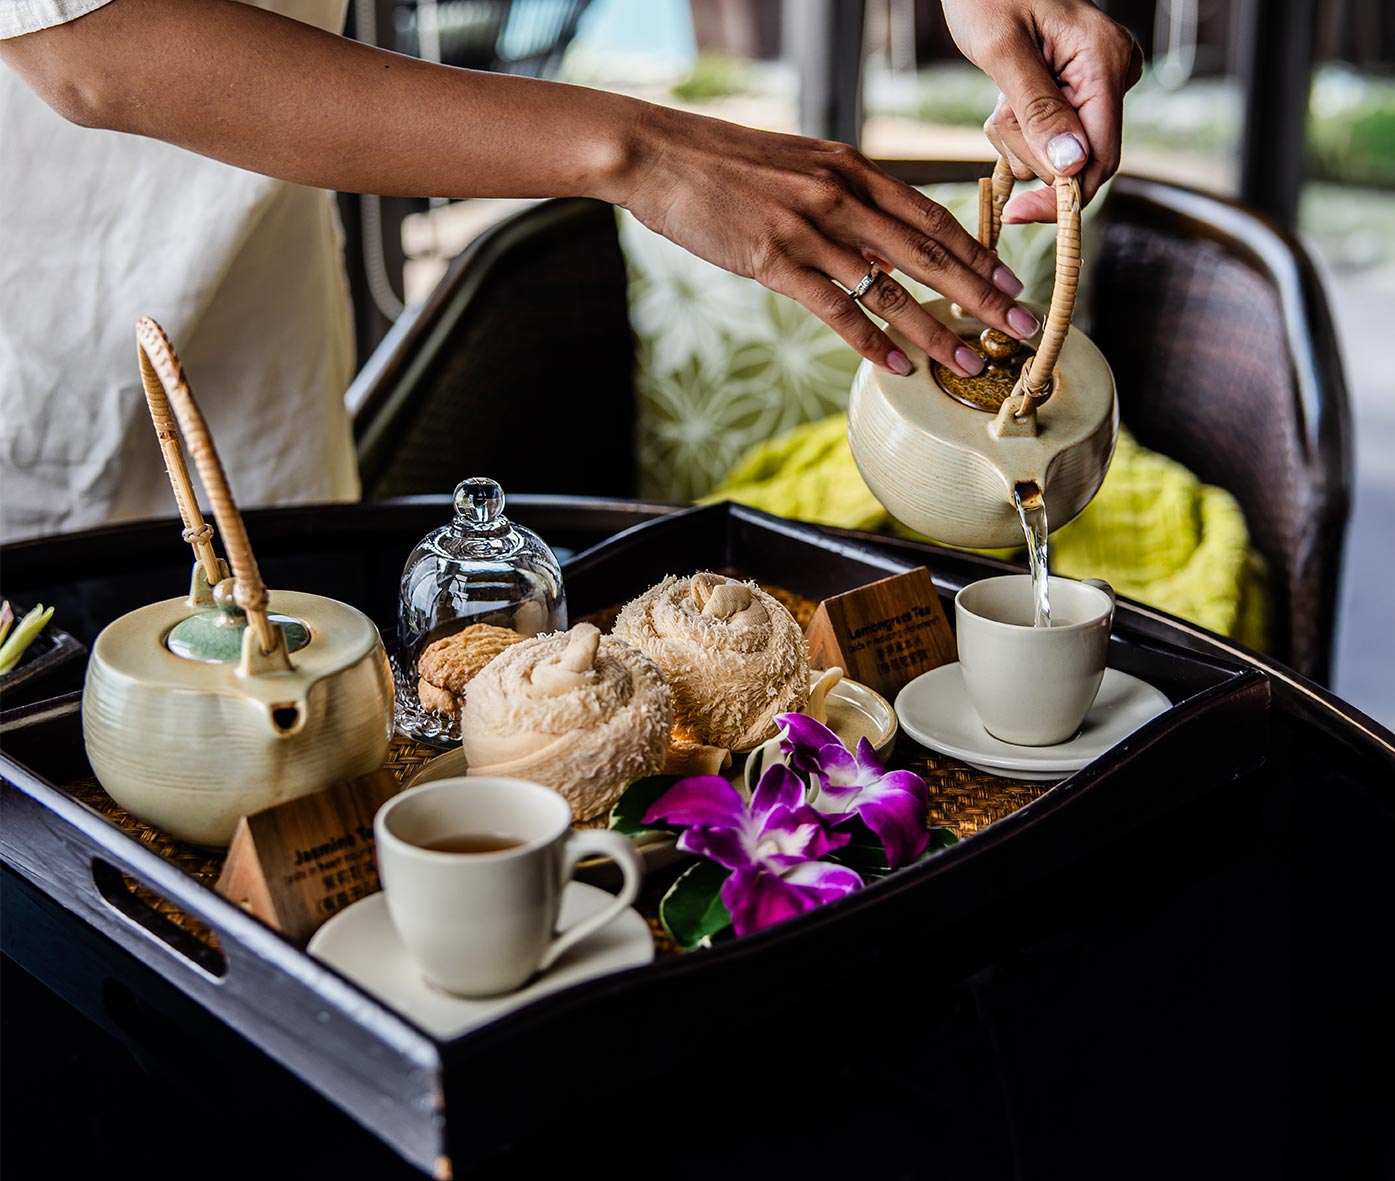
306;881;654;1042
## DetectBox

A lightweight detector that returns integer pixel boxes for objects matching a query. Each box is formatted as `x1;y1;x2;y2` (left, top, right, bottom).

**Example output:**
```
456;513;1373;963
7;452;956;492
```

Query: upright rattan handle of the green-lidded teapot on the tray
135;317;285;653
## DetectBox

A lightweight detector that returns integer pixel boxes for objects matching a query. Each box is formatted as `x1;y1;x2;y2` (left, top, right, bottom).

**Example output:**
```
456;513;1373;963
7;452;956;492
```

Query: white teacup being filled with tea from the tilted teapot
954;574;1115;746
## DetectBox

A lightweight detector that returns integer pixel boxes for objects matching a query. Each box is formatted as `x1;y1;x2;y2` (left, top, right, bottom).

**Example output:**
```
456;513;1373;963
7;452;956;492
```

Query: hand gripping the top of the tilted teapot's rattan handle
944;0;1143;222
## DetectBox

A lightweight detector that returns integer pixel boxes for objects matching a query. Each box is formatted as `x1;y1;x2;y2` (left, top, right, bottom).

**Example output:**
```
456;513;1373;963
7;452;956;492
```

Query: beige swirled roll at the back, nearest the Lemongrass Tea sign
614;573;809;752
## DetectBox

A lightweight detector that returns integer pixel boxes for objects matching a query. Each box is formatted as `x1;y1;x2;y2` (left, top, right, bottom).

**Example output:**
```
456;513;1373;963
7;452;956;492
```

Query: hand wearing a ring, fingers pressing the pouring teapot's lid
615;107;1055;376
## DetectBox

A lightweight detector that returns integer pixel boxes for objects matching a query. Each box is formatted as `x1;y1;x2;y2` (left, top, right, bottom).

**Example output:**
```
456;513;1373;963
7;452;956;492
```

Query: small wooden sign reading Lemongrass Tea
805;566;957;701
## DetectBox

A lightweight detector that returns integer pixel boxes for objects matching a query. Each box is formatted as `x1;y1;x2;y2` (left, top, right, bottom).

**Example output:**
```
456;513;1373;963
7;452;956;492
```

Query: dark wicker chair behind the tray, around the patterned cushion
348;168;1350;682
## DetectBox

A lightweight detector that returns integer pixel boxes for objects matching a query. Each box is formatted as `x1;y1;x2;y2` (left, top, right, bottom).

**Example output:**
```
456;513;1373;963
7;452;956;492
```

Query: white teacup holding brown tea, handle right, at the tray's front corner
374;775;644;997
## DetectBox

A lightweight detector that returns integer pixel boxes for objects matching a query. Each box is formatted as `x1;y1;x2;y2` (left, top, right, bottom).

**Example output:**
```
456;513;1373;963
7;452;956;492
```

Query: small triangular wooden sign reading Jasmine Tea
218;770;400;947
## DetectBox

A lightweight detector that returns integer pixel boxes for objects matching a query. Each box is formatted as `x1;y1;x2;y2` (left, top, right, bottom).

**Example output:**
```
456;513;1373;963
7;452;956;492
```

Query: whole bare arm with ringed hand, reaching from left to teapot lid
0;0;1038;375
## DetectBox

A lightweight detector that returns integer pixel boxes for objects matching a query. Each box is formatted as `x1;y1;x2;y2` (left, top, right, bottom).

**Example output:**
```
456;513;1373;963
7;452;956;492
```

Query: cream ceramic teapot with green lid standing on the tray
82;319;392;846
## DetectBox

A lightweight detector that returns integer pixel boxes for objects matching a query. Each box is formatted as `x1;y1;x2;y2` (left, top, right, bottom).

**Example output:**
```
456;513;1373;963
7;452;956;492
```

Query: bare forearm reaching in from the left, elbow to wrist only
0;0;647;202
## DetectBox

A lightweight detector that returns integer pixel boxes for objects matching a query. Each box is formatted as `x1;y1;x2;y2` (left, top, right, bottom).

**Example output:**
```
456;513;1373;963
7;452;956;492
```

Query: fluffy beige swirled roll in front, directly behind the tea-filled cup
460;623;674;823
